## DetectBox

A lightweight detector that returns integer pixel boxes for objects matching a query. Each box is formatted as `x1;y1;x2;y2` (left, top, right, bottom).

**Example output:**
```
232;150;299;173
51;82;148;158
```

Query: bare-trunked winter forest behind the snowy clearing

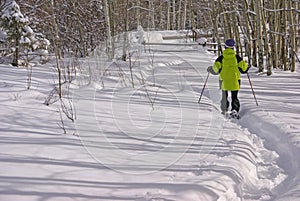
0;0;300;75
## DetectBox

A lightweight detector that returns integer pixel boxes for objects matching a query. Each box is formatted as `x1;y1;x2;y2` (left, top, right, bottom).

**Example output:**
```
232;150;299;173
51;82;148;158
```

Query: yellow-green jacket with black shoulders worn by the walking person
212;48;248;91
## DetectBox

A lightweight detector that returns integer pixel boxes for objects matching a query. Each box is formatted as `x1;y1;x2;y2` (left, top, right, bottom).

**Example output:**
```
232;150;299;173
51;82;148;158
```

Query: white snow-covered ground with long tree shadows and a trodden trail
0;30;300;201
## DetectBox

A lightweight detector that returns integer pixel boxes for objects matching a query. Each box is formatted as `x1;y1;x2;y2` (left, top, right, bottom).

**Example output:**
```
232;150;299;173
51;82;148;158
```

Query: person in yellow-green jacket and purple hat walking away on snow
207;39;249;114
